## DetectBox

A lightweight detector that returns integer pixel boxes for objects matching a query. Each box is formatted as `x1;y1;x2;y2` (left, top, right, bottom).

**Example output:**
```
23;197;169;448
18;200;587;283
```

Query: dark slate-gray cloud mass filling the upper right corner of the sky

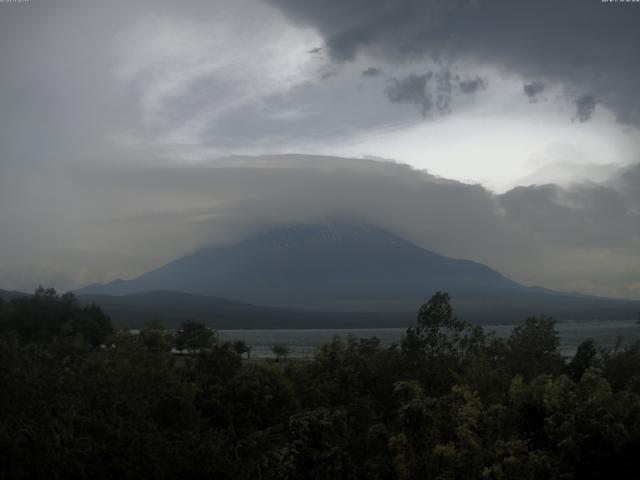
270;0;640;125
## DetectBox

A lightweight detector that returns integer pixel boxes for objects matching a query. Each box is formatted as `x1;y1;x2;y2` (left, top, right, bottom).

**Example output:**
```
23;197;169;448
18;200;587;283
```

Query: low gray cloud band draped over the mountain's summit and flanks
0;155;640;298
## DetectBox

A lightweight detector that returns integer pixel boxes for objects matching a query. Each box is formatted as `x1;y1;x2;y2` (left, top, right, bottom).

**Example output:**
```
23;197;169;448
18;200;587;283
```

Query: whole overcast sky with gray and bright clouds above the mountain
0;0;640;298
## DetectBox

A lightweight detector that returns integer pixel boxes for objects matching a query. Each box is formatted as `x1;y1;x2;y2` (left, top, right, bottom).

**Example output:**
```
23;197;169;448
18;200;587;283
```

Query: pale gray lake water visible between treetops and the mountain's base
219;320;640;358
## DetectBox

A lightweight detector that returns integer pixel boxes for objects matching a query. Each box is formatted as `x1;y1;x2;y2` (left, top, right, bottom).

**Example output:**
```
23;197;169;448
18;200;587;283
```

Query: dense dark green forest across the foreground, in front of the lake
0;289;640;480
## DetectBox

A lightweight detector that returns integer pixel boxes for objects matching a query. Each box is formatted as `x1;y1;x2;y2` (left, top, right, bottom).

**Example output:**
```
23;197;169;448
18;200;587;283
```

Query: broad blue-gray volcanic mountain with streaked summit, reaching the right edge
78;221;637;322
